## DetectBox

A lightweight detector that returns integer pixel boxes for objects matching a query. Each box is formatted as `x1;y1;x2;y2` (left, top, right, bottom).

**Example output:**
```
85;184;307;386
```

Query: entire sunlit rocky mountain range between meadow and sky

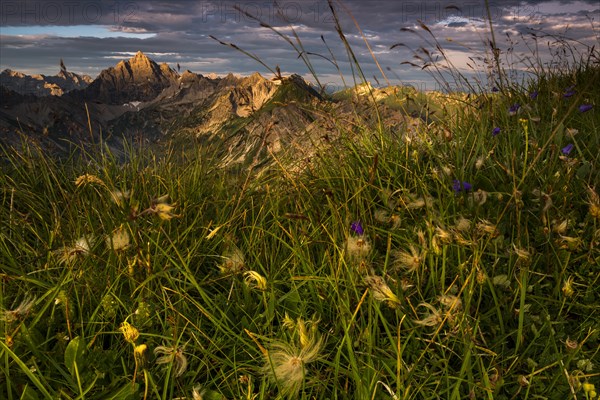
0;52;460;168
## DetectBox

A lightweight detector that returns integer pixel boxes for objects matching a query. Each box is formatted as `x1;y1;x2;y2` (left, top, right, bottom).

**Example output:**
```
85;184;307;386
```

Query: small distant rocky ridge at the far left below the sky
0;64;92;96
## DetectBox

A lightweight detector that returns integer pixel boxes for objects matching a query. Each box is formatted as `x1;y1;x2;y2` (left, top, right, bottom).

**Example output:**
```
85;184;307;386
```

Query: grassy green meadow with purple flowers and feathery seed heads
0;4;600;400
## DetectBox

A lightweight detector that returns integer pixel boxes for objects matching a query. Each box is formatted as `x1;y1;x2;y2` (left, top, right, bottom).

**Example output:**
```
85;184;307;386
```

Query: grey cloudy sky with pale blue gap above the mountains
0;0;600;90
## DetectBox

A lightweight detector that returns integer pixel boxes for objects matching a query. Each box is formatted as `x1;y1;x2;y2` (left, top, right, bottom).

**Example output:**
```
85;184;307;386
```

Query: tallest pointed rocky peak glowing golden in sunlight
78;51;179;104
